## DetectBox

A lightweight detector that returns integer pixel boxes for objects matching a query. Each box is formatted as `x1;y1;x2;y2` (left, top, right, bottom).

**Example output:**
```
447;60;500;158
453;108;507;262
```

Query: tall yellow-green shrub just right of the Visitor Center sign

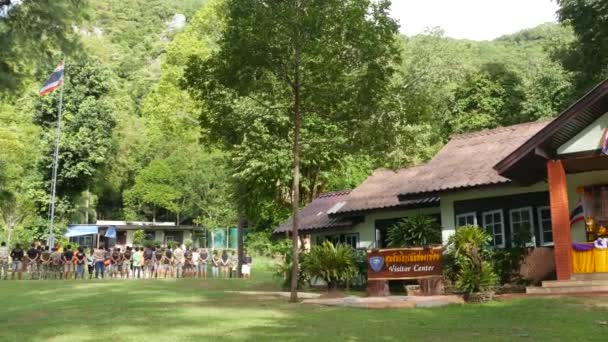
446;226;498;293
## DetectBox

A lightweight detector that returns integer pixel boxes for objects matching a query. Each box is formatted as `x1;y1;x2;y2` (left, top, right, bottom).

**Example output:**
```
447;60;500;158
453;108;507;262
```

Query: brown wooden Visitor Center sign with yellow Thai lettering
367;246;443;280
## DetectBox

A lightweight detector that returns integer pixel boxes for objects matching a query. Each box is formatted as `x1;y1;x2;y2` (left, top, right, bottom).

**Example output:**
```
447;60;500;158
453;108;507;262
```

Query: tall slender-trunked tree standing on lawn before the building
185;0;398;301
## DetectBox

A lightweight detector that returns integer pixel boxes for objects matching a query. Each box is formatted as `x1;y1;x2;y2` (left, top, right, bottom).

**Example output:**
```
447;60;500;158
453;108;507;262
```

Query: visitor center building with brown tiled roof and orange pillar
275;80;608;293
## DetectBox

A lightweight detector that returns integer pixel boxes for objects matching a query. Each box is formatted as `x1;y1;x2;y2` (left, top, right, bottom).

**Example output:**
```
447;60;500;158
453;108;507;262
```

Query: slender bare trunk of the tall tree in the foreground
290;42;302;302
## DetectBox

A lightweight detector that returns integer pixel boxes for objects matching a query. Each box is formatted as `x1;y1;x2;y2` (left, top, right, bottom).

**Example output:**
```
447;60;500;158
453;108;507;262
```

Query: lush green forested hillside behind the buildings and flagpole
0;0;608;246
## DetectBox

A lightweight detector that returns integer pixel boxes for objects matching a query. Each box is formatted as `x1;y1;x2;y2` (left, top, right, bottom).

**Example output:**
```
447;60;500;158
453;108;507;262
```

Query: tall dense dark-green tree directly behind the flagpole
34;56;116;206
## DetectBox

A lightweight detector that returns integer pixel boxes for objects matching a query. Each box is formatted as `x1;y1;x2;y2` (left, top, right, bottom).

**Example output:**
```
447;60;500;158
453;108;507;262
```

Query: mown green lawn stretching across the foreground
0;264;608;342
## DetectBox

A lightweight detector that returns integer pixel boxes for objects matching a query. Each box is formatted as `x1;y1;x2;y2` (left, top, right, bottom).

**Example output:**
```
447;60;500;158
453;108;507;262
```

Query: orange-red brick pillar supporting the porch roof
547;160;572;280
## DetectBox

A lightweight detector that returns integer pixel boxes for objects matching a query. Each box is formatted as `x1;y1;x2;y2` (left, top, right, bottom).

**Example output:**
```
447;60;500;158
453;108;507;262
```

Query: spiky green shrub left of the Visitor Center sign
302;241;357;290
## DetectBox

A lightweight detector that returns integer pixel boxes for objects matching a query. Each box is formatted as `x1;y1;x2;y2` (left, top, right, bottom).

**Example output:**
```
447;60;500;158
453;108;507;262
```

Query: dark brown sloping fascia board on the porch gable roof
494;79;608;176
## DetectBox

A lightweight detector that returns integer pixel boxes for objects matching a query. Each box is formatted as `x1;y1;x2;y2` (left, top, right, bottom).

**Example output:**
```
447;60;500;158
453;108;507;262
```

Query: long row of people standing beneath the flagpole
0;242;252;280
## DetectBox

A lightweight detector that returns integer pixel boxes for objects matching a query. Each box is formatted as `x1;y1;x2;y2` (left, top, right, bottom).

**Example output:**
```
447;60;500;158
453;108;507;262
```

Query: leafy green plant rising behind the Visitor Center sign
388;214;441;247
